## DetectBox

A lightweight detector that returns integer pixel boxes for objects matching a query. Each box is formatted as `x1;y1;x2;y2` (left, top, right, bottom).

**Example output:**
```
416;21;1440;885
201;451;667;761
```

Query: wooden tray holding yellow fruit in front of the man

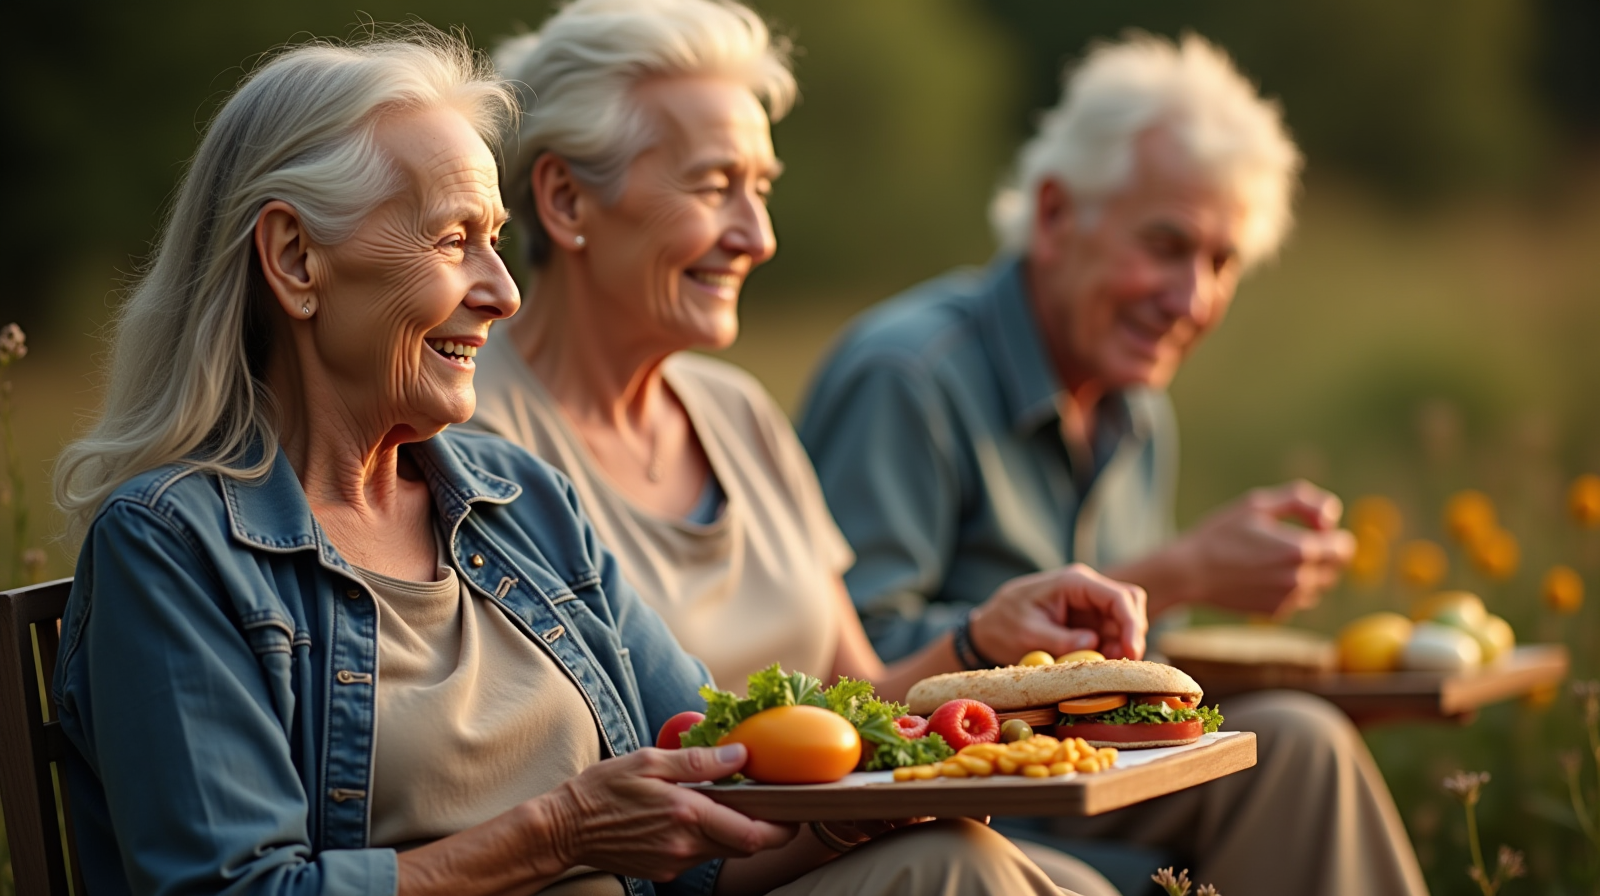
1173;645;1571;720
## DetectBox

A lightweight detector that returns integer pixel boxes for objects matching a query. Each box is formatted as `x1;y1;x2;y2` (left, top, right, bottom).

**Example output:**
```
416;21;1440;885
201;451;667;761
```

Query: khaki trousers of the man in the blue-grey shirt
1004;691;1427;896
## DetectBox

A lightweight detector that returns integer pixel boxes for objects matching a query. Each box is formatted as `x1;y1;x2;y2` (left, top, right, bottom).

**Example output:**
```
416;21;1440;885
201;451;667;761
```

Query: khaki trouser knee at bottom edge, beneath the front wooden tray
768;819;1075;896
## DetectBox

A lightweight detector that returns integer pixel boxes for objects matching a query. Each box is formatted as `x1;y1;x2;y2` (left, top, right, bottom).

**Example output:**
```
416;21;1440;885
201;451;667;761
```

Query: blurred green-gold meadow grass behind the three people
0;184;1600;894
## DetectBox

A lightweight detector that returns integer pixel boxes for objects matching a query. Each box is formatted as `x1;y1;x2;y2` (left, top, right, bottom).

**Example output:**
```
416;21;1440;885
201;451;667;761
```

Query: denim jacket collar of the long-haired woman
221;437;522;565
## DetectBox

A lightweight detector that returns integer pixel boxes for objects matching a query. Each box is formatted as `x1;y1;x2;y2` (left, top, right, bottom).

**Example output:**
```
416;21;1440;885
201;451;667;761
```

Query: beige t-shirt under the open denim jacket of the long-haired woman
357;550;624;896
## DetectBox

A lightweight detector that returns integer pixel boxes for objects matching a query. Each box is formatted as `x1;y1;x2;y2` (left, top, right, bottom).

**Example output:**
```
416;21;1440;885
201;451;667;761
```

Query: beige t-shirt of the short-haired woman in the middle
470;339;854;691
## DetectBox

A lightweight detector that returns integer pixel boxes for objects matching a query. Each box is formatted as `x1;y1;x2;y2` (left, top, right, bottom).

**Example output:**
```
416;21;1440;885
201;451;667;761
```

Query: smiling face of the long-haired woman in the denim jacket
310;109;518;442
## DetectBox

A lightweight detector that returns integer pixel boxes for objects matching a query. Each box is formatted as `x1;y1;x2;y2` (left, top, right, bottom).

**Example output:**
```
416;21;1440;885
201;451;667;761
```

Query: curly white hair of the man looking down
989;34;1301;267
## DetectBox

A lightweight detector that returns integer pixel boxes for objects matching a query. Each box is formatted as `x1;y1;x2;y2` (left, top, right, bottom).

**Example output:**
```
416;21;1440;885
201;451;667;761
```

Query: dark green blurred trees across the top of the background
0;0;1600;333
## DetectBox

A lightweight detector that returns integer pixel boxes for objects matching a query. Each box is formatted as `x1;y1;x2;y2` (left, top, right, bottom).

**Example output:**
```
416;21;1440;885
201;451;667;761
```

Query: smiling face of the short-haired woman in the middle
582;78;779;350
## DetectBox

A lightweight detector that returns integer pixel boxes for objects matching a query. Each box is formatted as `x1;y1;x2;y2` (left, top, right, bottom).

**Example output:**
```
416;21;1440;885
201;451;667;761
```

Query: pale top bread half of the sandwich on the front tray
906;659;1205;715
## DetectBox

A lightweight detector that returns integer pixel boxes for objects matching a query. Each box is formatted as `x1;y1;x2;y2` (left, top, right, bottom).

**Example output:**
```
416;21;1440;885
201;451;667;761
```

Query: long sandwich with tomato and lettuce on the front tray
906;659;1222;749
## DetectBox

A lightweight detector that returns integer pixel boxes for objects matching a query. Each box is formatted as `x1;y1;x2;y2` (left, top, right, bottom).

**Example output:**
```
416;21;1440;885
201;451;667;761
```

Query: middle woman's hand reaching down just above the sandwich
973;563;1149;662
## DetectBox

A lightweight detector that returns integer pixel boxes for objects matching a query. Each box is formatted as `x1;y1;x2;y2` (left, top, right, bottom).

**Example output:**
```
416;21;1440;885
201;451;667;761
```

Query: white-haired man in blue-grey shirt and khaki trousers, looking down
800;37;1426;896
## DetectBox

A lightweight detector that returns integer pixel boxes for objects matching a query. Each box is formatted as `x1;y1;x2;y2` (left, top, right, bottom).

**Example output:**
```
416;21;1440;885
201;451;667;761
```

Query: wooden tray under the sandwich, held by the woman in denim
686;731;1256;821
